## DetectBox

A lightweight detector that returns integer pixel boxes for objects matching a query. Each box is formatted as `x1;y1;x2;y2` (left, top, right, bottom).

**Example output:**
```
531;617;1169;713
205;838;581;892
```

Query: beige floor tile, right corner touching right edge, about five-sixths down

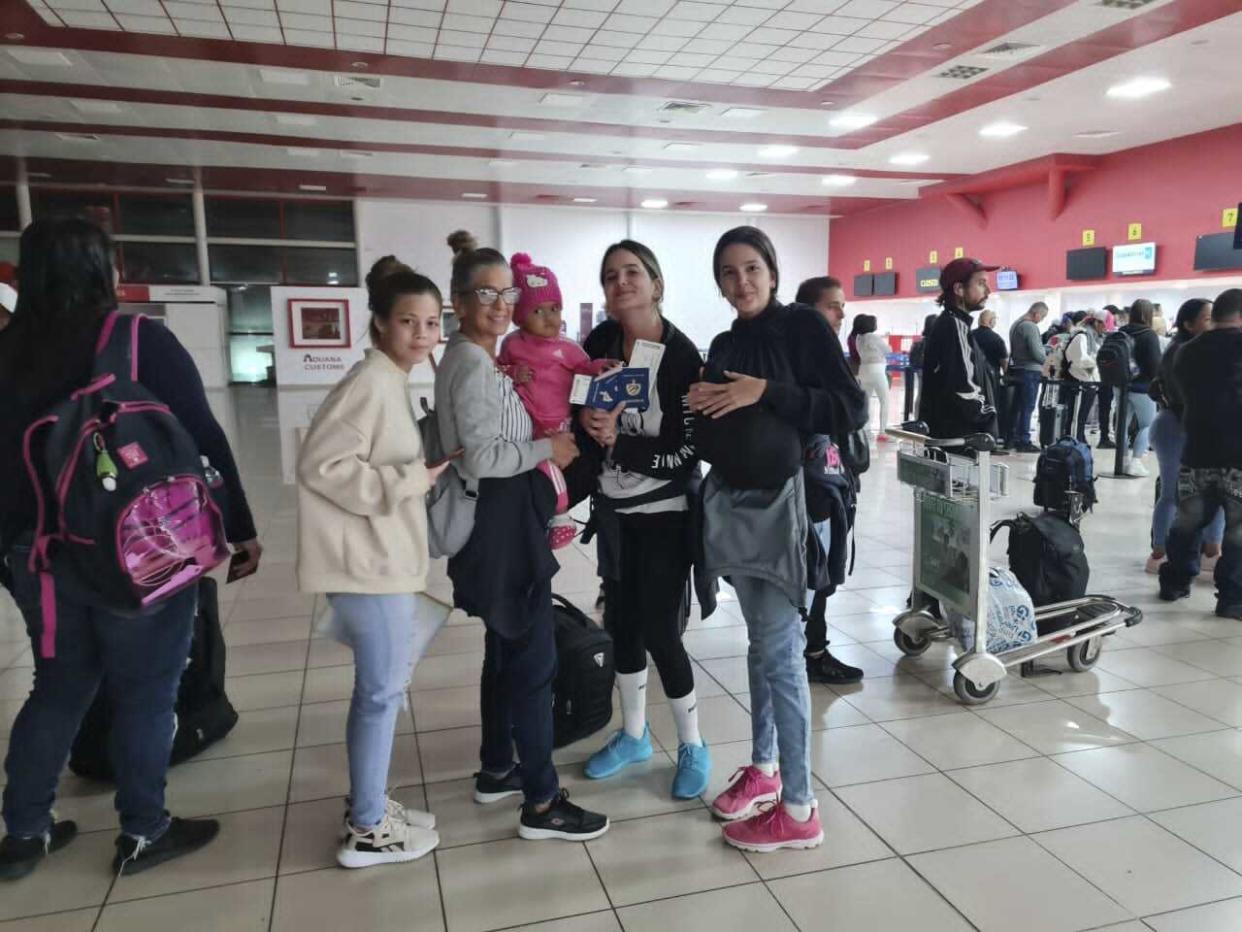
1053;744;1237;813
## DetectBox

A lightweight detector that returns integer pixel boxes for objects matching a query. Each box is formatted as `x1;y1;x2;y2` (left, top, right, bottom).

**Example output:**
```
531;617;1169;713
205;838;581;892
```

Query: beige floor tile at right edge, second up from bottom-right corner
1035;816;1242;916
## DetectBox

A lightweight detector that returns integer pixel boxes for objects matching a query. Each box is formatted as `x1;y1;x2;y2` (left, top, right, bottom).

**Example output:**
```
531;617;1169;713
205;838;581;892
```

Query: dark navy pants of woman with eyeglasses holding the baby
479;582;560;803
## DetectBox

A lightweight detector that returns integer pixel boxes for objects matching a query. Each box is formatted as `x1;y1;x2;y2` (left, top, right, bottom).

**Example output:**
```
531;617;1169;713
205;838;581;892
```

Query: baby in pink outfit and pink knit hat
496;252;616;549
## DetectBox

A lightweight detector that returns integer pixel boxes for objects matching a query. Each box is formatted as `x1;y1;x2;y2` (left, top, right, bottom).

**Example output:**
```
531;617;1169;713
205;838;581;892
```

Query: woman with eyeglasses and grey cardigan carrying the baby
436;249;609;841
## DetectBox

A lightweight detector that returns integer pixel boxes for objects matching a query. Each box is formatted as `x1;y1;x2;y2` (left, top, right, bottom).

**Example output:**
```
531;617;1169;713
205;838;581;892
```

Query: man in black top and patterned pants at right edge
1160;288;1242;621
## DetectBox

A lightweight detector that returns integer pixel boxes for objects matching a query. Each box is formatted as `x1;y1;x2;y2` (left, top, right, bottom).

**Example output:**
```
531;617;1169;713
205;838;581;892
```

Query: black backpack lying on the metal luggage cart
992;512;1090;606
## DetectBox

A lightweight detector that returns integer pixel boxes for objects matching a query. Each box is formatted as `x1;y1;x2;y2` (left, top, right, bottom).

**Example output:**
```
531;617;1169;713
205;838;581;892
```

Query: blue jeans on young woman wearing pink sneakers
729;577;815;805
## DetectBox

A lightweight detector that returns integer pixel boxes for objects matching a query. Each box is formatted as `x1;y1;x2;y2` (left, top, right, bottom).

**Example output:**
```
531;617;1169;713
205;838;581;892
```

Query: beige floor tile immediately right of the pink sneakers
836;773;1017;855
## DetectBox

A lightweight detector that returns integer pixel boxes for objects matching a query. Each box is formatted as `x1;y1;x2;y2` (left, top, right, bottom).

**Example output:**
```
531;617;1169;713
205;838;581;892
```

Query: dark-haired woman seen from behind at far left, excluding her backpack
0;219;261;879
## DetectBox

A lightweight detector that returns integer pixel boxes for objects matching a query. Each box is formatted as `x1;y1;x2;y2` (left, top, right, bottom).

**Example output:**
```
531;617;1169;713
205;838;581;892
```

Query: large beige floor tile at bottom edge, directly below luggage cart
910;838;1129;932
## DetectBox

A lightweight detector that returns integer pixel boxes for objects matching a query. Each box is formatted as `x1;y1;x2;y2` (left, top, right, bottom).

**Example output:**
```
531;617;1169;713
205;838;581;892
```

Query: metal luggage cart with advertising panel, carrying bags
888;429;1143;705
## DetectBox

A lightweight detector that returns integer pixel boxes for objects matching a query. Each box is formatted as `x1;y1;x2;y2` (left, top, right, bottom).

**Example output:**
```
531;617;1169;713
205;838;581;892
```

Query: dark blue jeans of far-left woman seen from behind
4;547;197;840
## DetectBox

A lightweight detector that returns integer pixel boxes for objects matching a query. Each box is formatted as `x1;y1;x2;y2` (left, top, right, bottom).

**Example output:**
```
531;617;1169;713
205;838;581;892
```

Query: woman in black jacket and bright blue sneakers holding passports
580;240;712;799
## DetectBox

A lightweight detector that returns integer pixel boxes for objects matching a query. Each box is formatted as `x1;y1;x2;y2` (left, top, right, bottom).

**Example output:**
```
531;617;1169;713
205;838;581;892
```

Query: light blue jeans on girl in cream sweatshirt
328;593;443;829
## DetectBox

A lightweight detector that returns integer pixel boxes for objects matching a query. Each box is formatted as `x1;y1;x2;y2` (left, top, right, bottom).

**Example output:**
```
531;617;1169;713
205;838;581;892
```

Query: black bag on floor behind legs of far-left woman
70;578;237;780
